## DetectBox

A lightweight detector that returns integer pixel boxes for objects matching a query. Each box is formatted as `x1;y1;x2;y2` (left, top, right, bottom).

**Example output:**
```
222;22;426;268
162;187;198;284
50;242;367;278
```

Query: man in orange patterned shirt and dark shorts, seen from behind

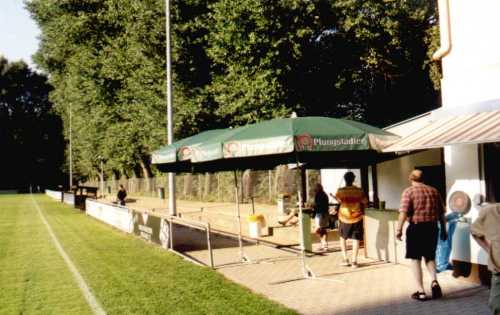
335;172;368;268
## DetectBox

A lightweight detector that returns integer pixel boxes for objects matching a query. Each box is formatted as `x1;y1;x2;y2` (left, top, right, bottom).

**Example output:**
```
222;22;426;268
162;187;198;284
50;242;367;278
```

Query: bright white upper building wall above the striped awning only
440;0;500;107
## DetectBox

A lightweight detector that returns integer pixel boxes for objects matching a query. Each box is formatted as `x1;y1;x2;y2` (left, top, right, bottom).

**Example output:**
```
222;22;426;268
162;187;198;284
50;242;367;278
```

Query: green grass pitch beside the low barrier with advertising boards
0;195;294;314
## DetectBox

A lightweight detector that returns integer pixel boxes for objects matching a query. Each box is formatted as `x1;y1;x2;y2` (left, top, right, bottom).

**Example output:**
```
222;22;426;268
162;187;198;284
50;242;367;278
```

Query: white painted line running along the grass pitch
30;194;106;315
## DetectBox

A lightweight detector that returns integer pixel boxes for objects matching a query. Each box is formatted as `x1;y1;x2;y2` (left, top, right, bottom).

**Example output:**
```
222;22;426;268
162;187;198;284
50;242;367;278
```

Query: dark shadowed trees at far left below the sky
0;56;64;189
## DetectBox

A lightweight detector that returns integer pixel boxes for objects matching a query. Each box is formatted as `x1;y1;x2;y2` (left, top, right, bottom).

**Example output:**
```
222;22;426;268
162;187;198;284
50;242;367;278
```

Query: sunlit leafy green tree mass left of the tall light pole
28;0;165;181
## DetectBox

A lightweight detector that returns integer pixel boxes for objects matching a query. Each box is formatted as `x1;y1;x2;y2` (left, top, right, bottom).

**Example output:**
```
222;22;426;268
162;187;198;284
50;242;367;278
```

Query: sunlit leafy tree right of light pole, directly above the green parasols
208;0;331;124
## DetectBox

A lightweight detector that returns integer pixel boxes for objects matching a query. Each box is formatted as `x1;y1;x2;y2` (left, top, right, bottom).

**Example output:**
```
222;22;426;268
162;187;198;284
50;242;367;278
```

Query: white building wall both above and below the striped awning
440;0;500;264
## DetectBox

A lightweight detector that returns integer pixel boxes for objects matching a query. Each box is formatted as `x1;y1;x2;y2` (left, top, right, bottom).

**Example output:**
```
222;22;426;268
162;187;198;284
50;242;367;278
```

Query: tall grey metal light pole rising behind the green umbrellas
165;0;177;215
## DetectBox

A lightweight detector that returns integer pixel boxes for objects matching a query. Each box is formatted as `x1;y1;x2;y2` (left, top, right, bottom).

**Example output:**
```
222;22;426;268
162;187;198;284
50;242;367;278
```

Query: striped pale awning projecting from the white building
384;110;500;152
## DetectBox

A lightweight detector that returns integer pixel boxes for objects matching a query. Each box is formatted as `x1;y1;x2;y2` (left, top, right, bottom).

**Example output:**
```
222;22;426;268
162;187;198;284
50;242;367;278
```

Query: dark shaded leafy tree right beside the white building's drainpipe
332;0;438;126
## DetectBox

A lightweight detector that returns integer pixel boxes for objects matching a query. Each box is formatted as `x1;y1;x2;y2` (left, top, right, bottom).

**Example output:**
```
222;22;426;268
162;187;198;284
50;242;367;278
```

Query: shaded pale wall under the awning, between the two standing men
377;149;442;209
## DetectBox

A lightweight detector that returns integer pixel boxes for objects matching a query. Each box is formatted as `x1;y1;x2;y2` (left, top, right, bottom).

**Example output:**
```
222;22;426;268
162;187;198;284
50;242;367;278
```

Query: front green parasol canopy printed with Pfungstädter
186;117;399;171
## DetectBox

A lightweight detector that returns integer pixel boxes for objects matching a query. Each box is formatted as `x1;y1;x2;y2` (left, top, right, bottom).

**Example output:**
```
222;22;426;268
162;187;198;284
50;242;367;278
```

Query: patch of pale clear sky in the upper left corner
0;0;40;66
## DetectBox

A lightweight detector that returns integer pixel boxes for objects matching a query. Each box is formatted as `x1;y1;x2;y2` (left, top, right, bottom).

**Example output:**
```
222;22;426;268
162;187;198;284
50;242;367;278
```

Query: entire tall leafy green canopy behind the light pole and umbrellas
27;0;439;181
